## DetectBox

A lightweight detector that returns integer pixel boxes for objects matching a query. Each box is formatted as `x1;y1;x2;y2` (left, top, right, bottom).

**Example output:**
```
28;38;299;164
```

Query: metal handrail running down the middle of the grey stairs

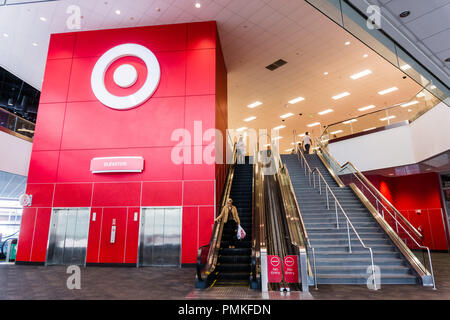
297;147;378;290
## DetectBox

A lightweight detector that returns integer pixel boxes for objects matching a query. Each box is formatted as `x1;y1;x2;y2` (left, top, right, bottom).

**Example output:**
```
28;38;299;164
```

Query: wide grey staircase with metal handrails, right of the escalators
282;154;420;284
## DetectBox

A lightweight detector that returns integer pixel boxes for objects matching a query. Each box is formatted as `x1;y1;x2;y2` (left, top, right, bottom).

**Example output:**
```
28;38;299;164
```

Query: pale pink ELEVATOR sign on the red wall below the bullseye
91;157;144;173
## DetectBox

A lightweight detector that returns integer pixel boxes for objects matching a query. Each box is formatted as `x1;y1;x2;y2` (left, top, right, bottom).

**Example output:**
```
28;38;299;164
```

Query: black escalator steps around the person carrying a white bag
214;157;253;287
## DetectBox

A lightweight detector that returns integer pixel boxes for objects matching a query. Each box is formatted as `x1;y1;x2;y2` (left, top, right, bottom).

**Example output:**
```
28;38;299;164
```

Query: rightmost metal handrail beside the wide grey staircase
316;139;436;289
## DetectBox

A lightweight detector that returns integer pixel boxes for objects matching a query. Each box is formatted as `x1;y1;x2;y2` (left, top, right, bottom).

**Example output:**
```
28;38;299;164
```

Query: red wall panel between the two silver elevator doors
99;208;127;263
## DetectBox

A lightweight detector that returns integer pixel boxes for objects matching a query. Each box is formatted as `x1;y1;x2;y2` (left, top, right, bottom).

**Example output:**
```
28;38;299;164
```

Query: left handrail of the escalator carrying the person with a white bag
197;143;237;281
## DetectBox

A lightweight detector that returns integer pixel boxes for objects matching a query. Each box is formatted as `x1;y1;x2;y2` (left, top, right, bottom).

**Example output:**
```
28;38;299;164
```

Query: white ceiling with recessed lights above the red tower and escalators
0;0;428;151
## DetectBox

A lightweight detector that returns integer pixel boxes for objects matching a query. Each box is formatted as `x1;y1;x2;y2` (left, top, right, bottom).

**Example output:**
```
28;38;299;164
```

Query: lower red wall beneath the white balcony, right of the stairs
367;173;447;250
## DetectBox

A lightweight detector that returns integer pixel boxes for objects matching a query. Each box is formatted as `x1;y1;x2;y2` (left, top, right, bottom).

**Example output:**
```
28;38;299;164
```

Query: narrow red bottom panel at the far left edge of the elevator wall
16;208;36;261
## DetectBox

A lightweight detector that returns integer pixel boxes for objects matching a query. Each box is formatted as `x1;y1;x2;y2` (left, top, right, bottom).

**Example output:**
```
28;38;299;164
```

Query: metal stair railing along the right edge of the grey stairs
316;139;436;289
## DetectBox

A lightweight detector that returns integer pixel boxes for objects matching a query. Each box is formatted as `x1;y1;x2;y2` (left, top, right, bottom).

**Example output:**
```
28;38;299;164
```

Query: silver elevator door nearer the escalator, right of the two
139;207;182;266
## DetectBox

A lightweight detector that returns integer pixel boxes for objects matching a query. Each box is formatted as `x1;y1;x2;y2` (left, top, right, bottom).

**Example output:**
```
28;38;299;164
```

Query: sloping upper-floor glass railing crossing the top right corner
306;0;450;106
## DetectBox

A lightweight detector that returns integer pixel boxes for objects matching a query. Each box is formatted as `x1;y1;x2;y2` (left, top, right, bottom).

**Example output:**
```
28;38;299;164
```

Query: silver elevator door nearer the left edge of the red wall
46;208;89;265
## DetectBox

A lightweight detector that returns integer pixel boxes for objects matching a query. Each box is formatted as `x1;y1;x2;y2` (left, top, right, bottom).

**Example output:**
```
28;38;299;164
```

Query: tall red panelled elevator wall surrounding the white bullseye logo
17;22;228;263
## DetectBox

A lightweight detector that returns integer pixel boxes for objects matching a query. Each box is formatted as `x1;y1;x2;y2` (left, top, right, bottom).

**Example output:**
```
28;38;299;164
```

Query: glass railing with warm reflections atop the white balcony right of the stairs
321;89;441;143
